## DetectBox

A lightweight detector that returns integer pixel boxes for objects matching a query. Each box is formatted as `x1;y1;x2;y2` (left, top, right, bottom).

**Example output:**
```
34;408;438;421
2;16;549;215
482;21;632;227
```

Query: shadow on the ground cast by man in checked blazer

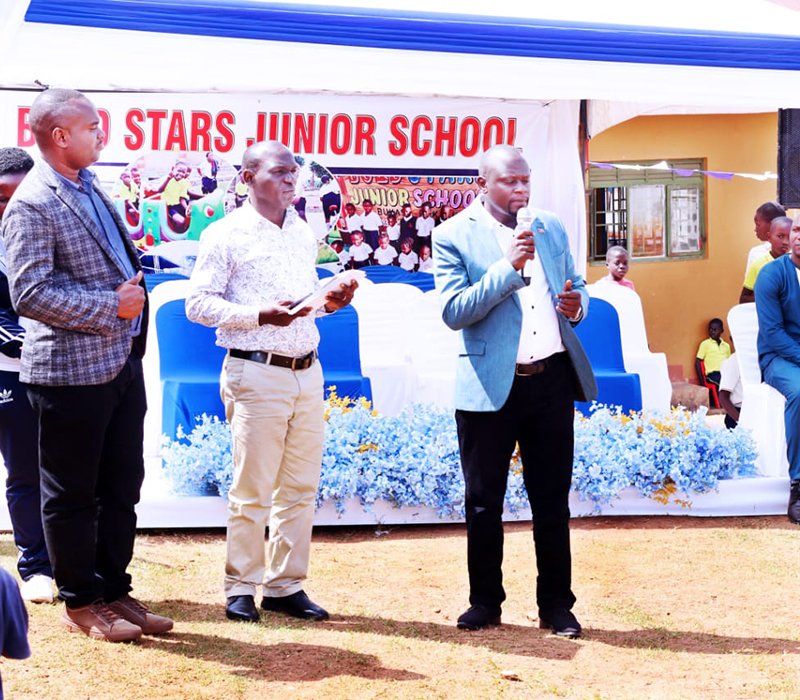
141;623;424;682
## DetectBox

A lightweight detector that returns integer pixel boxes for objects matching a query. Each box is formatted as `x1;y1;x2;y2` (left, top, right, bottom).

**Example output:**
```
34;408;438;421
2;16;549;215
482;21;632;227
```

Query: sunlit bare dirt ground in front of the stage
0;517;800;699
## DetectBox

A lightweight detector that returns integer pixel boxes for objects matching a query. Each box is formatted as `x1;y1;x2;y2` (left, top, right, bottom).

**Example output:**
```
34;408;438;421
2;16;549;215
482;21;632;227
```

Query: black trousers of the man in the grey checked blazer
28;355;147;608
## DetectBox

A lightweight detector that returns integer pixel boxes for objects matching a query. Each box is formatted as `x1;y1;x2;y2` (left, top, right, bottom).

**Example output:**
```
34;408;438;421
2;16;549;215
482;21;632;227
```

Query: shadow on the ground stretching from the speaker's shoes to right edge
584;627;800;656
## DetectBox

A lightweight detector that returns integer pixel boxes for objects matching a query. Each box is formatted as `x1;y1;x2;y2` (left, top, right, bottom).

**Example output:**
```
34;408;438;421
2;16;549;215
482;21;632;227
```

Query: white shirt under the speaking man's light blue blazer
481;196;565;364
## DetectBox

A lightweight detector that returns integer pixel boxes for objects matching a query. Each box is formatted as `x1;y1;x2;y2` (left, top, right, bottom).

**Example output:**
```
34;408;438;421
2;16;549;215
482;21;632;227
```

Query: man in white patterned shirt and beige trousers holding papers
186;141;357;621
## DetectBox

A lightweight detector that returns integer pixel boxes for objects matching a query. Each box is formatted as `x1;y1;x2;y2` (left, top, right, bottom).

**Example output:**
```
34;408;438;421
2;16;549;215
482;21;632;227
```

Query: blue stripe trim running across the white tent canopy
25;0;800;72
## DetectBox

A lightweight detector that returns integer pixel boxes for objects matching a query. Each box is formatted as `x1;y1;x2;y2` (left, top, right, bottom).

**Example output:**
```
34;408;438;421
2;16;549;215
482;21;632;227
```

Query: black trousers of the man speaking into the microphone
456;353;575;611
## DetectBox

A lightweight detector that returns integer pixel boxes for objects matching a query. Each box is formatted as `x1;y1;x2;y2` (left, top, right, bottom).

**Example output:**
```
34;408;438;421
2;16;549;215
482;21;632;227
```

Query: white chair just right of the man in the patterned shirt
353;282;422;416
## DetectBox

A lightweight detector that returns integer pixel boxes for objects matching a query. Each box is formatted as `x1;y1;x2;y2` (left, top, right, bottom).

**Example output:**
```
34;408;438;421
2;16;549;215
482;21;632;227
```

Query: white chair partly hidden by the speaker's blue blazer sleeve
409;289;458;408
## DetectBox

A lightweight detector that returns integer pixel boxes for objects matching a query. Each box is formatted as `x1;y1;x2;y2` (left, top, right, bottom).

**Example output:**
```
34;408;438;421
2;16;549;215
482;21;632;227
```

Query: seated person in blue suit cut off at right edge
754;211;800;525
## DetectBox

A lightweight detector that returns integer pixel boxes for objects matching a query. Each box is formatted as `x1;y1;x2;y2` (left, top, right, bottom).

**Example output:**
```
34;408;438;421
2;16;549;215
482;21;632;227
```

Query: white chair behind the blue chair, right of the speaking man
587;282;672;411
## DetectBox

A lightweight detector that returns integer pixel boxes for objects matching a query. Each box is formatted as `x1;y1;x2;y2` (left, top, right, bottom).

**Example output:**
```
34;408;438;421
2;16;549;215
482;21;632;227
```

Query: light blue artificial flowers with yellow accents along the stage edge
162;391;757;517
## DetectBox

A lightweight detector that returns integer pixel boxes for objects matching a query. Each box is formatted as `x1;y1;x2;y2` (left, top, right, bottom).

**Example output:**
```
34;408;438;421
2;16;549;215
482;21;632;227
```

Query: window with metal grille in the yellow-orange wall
588;159;705;260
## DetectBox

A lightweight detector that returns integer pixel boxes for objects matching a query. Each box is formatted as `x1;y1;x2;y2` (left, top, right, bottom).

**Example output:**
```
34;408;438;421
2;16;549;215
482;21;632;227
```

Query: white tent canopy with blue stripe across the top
0;0;800;121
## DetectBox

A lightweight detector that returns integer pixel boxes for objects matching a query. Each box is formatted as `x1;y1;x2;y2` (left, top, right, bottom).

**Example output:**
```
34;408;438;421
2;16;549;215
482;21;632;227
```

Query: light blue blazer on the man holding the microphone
433;199;597;411
